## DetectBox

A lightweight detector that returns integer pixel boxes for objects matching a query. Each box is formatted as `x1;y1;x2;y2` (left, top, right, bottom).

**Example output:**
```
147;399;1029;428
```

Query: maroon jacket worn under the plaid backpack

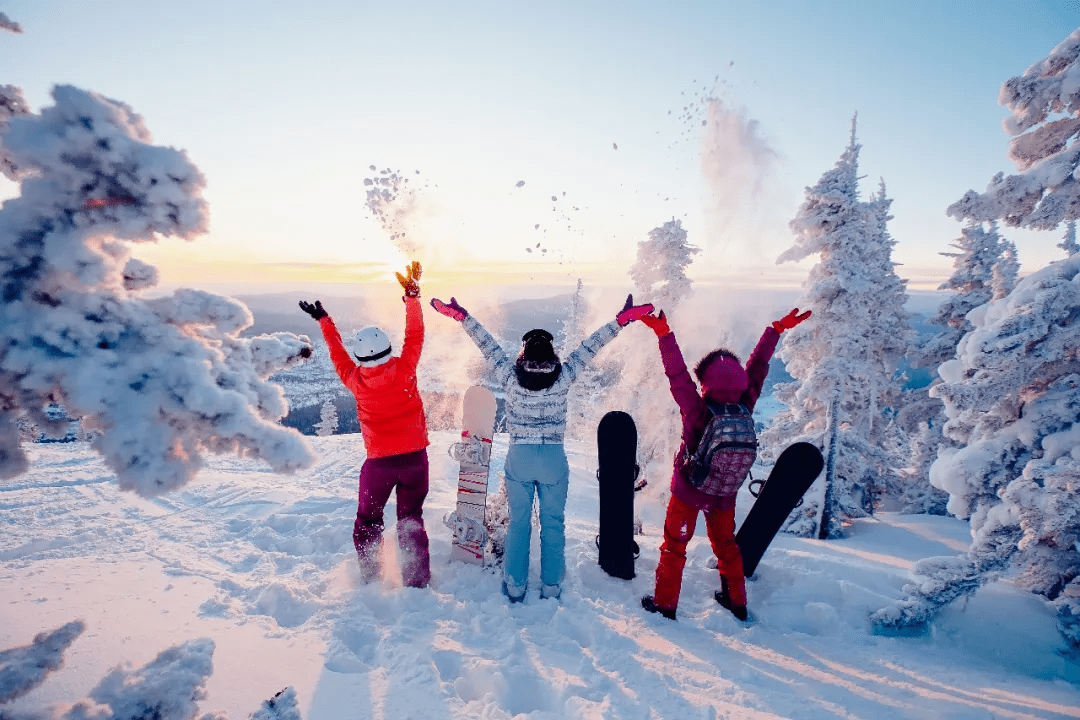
660;327;780;512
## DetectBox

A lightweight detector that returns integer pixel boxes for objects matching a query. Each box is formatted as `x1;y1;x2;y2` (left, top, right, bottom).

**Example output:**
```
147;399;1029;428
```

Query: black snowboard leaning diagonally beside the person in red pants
735;443;825;578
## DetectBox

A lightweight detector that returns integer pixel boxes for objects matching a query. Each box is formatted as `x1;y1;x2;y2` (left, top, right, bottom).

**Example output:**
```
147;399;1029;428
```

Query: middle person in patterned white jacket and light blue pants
431;296;652;602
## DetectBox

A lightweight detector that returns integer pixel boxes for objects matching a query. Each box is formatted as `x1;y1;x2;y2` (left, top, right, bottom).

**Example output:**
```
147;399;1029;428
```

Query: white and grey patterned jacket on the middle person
461;315;622;445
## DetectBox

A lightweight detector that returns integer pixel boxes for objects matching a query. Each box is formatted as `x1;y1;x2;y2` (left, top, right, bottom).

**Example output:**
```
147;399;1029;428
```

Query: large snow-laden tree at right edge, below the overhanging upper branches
875;256;1080;647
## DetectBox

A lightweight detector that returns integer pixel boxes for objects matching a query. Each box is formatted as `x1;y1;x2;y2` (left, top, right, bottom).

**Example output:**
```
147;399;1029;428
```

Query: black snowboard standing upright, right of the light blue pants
596;410;637;580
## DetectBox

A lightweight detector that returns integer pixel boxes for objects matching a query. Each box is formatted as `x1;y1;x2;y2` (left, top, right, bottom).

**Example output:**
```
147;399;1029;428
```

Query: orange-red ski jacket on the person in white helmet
319;297;428;458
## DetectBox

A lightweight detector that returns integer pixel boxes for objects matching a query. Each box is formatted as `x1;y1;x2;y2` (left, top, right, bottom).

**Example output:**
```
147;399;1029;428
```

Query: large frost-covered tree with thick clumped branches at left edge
0;85;313;494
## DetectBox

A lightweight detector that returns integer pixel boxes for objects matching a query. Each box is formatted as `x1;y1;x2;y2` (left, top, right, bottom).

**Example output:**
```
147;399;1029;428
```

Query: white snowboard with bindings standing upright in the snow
444;385;496;565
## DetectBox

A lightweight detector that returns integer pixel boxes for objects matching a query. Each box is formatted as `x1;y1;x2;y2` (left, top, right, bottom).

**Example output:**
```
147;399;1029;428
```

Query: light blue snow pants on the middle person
503;443;570;596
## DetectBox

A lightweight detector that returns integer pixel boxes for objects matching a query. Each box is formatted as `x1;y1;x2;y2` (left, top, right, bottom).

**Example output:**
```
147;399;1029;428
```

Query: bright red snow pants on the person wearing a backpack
653;494;746;610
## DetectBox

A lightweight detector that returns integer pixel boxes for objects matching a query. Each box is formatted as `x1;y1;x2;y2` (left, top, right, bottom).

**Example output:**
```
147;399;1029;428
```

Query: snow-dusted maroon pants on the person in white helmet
352;450;431;587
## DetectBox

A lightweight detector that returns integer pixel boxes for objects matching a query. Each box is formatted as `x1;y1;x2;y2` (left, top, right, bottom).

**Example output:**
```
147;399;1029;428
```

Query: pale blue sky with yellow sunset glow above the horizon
0;0;1080;295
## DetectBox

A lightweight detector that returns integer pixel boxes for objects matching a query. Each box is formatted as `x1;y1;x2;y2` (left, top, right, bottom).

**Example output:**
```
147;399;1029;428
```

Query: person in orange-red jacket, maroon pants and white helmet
300;262;431;587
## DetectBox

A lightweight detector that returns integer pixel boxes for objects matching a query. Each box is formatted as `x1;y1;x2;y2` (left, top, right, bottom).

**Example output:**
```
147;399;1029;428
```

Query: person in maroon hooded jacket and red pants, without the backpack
642;308;810;620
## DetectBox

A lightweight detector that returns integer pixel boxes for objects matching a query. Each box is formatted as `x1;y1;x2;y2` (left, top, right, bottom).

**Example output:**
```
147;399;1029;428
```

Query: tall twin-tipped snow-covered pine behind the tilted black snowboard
761;119;912;538
